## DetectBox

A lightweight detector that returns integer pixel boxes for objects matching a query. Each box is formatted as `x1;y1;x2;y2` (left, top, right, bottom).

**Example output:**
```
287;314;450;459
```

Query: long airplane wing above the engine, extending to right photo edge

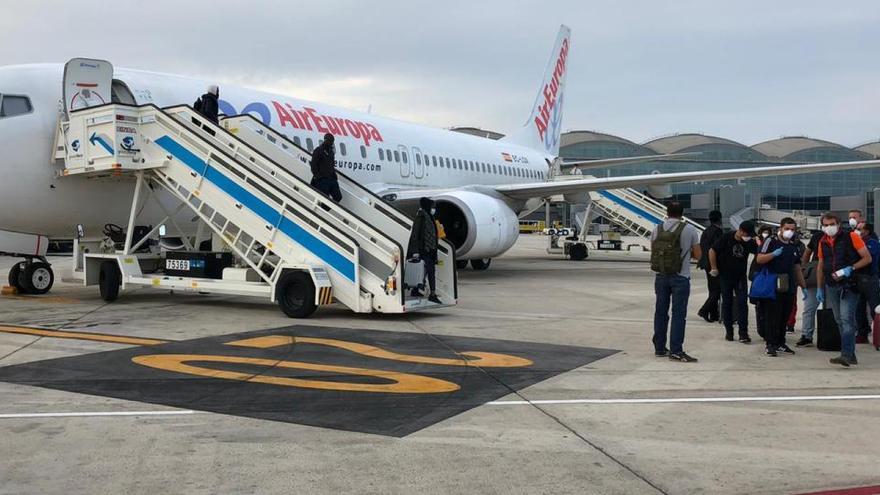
489;160;880;199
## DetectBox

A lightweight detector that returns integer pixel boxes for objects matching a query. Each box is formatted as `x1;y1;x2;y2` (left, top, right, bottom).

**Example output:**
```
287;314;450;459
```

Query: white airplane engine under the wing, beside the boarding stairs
434;191;519;260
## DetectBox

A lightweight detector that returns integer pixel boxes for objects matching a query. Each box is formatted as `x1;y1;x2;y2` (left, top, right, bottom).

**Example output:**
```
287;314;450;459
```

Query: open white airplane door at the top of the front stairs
64;58;113;118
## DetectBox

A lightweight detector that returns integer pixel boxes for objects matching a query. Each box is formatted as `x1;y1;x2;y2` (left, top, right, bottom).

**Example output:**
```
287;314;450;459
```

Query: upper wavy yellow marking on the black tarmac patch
226;335;533;368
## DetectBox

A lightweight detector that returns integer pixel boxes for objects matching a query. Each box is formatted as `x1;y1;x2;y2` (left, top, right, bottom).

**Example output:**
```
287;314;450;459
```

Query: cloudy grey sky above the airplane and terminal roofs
0;0;880;145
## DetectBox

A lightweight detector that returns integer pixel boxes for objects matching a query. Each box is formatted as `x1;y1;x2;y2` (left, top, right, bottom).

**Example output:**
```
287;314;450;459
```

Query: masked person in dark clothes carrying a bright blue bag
756;217;807;357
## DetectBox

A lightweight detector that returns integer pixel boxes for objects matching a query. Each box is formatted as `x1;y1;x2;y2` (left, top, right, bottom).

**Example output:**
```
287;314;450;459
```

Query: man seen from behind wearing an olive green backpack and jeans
651;201;702;363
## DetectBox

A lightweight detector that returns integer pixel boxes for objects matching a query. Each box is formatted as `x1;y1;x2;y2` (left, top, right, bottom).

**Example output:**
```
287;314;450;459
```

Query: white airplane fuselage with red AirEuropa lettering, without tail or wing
0;64;553;238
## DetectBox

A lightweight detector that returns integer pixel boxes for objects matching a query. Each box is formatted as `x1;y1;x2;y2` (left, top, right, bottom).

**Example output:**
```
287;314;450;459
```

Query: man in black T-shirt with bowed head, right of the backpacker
709;221;758;344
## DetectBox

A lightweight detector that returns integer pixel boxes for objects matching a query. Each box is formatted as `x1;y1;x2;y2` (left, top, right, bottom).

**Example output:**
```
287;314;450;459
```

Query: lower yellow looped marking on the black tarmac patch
131;354;460;394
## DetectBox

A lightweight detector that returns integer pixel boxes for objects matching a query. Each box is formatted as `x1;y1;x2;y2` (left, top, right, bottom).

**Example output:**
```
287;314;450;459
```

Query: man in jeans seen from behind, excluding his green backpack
651;201;702;363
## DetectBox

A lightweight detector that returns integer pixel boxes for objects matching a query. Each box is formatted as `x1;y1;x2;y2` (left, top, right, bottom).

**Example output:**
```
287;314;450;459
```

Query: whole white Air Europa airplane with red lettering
0;26;880;294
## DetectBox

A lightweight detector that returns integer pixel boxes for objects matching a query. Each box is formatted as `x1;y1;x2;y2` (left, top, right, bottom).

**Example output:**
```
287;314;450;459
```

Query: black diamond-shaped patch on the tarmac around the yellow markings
0;325;617;437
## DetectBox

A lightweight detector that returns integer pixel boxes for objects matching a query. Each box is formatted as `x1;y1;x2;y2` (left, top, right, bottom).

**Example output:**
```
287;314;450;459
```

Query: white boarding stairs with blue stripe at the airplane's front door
55;104;457;316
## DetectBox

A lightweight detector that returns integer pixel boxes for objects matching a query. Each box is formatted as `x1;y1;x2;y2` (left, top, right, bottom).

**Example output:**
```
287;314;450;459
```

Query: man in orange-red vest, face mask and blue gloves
816;212;872;367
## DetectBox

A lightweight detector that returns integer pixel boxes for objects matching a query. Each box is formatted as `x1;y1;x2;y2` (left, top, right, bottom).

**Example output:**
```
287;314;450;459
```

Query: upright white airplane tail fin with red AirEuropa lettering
503;25;571;157
